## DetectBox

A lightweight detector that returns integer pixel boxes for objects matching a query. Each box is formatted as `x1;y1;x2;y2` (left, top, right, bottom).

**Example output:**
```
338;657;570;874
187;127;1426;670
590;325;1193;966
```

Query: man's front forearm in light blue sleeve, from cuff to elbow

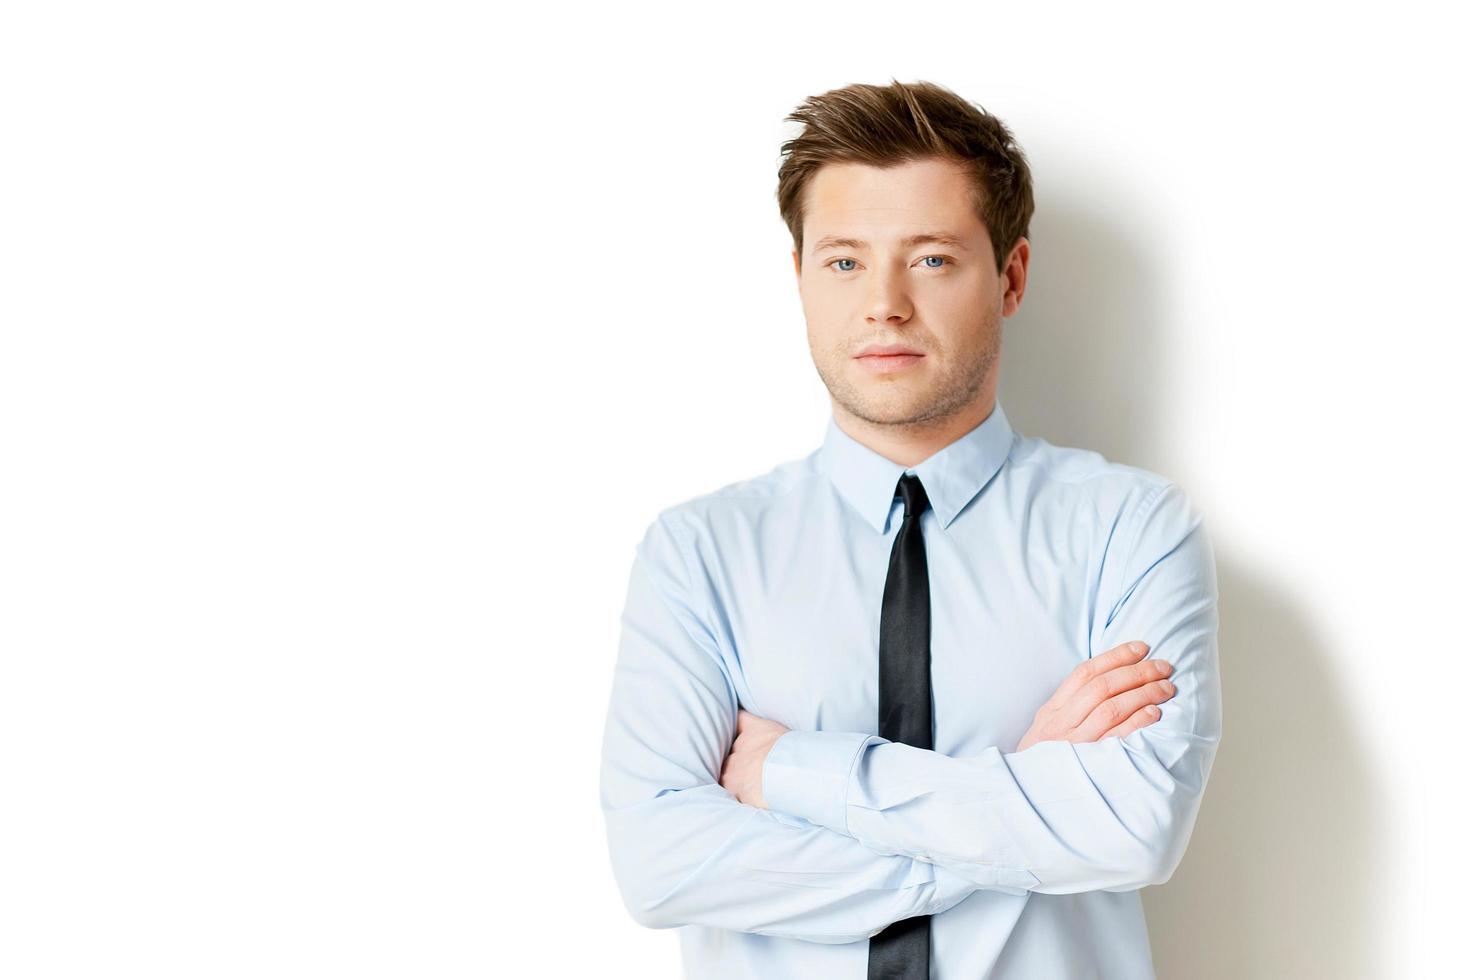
764;716;1205;895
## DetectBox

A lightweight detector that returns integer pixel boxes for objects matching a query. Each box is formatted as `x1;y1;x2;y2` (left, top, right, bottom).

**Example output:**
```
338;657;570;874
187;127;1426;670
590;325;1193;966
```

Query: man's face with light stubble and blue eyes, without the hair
792;159;1027;426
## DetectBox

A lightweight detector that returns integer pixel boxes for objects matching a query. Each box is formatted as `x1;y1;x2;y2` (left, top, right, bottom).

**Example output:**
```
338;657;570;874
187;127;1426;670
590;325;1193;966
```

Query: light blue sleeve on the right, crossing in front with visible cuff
763;483;1223;895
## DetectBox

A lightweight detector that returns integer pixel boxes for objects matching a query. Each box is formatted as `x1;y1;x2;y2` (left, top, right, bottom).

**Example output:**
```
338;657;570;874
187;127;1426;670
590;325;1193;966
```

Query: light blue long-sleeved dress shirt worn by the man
600;404;1223;980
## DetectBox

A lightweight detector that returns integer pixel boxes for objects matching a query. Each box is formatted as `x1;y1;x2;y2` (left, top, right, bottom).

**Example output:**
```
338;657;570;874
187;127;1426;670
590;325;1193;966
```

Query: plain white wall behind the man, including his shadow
0;1;1473;980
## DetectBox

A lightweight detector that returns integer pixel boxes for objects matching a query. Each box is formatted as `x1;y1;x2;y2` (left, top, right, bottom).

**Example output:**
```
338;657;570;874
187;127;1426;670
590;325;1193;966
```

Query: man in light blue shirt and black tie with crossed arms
601;83;1221;980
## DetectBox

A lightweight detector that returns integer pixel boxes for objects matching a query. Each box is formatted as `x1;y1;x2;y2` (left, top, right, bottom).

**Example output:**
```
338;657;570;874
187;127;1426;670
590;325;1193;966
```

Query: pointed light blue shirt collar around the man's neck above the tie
819;401;1013;533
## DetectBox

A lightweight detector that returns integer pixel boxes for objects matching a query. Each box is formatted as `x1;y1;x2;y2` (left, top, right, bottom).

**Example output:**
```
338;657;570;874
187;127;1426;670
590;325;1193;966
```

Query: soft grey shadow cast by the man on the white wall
1000;194;1389;980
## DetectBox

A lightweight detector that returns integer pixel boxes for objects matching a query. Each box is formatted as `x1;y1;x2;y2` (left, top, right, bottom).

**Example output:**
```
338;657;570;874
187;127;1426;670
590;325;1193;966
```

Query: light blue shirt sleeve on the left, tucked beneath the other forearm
600;516;989;943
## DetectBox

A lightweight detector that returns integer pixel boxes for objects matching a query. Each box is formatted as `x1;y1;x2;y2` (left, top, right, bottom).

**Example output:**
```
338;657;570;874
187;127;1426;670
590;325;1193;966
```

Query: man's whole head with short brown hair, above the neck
778;81;1033;432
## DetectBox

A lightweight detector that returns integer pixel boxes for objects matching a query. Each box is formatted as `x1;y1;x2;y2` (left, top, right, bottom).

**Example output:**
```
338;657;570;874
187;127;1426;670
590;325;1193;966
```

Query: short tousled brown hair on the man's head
778;78;1033;273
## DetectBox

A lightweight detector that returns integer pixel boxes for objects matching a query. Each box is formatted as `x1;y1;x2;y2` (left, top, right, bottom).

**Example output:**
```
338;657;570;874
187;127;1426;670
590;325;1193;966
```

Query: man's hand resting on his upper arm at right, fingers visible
1016;643;1177;752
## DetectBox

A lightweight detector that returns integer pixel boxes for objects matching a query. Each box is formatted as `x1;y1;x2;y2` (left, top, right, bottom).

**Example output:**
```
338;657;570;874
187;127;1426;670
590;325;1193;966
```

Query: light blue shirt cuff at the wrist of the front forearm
762;731;884;834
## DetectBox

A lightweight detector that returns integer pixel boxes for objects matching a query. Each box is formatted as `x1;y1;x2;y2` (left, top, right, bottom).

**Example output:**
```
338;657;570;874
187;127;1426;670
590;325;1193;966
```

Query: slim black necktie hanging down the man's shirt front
868;473;932;980
